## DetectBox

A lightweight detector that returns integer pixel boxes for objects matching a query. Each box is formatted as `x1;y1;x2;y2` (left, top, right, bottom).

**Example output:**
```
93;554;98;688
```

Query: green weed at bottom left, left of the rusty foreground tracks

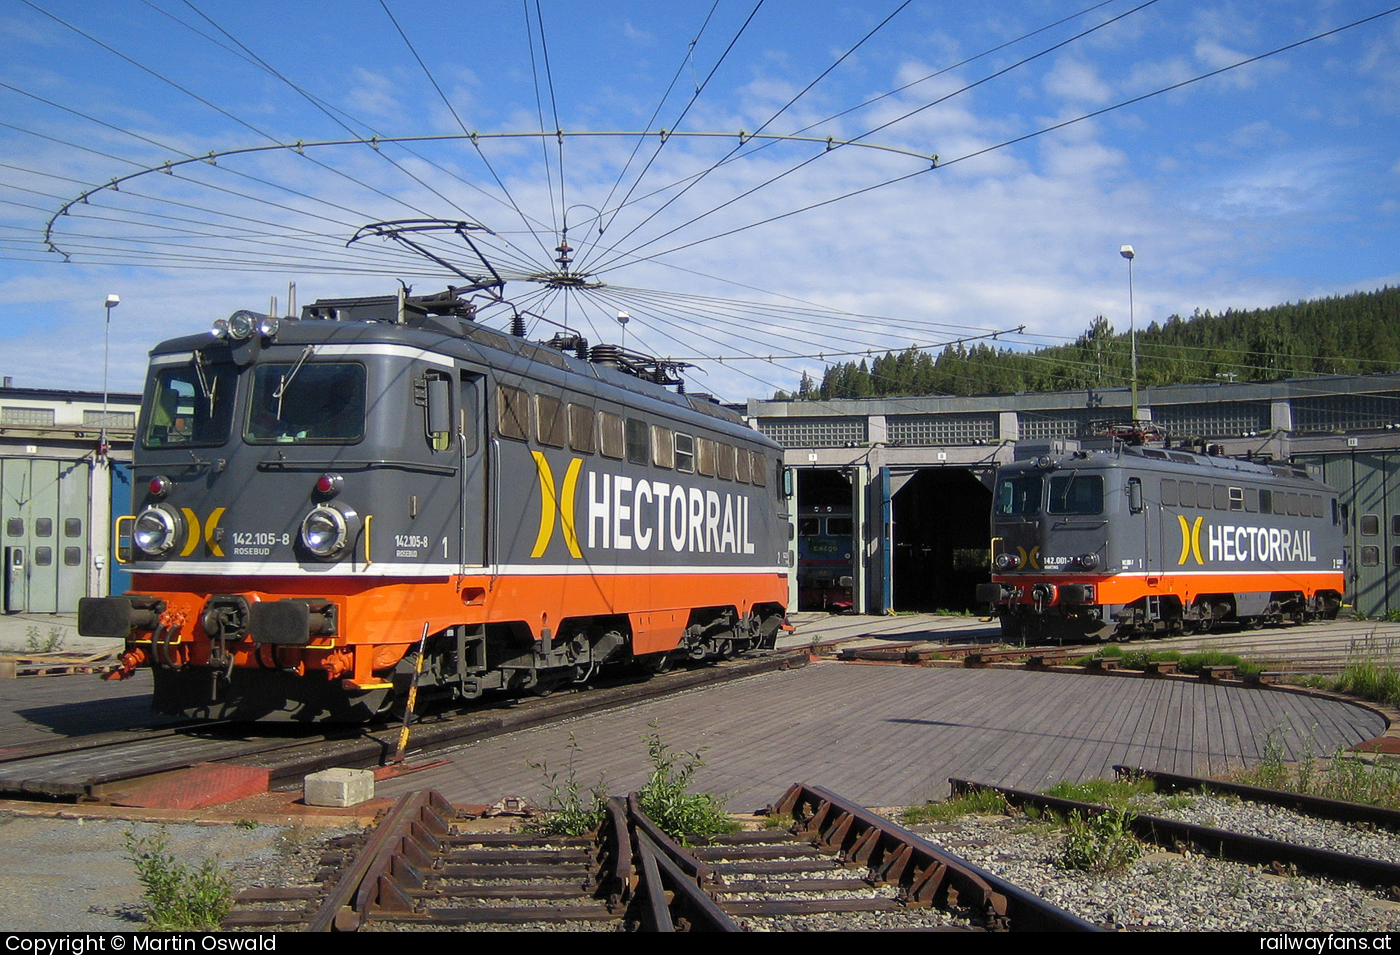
126;828;234;931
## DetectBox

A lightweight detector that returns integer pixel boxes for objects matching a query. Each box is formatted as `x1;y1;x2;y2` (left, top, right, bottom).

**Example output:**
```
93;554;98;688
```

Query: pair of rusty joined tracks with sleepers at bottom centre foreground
224;786;1096;931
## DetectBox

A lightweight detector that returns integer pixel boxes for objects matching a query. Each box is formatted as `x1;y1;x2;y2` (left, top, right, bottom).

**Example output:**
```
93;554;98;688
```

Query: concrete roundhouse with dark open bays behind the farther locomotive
746;374;1400;616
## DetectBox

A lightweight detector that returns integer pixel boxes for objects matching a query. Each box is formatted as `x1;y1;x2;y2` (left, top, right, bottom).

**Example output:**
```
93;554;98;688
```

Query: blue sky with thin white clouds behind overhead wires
0;0;1400;400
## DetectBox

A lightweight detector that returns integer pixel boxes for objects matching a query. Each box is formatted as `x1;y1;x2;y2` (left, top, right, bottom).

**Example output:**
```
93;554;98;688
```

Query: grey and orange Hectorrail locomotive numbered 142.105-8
80;298;787;720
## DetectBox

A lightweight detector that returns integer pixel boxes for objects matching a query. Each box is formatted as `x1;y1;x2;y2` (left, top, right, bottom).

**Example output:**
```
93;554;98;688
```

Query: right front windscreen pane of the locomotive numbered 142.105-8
244;360;365;444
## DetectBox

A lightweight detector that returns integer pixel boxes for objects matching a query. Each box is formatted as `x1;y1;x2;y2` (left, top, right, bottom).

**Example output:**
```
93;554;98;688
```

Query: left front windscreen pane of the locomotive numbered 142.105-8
144;363;238;448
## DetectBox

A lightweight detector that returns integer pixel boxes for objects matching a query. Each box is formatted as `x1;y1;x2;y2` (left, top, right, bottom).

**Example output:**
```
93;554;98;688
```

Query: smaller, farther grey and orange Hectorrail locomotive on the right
979;447;1344;641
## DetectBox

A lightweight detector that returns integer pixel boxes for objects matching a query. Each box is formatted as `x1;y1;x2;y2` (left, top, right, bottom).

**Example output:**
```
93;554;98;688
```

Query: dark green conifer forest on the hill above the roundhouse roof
774;287;1400;400
